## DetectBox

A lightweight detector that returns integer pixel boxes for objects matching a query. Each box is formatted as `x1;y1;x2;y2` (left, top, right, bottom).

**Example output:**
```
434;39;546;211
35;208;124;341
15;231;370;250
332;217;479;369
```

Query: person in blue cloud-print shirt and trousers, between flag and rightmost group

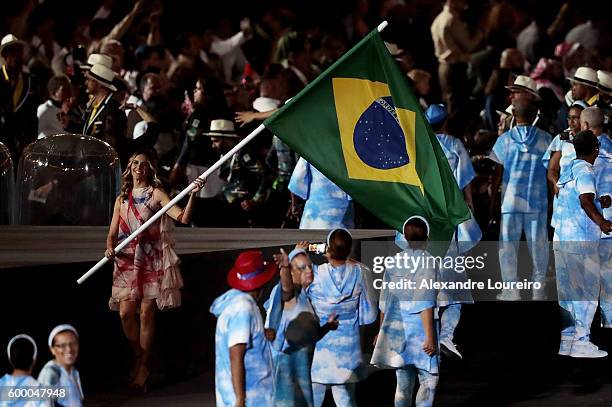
489;94;551;301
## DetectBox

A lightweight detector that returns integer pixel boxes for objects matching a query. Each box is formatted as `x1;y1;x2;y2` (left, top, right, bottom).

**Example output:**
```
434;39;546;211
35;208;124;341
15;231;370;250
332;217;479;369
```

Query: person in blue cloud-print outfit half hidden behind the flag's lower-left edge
289;158;355;229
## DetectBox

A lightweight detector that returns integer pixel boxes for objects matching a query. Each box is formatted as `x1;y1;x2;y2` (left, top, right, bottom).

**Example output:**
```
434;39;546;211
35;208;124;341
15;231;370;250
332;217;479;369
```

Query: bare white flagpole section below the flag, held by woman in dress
77;124;265;284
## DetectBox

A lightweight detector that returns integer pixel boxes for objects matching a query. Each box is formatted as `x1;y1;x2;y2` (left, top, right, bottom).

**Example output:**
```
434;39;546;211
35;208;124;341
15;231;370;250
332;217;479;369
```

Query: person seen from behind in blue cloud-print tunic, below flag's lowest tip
371;216;439;407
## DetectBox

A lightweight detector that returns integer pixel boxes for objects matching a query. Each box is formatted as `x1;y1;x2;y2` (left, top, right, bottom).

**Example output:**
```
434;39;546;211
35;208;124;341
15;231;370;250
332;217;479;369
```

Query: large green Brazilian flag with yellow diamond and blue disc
264;30;471;241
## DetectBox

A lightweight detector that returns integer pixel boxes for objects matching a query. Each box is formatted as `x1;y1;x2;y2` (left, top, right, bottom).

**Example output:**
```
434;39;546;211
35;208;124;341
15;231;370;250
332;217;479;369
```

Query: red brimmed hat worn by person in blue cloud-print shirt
227;250;276;291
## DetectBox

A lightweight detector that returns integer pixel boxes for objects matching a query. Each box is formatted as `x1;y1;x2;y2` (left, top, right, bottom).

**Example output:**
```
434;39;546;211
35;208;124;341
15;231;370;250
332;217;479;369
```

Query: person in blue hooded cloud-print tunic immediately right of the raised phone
306;229;376;407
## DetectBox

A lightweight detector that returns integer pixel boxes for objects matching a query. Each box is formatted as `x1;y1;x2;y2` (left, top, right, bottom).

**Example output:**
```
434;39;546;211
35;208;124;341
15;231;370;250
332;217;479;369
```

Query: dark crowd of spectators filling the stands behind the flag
0;0;612;231
